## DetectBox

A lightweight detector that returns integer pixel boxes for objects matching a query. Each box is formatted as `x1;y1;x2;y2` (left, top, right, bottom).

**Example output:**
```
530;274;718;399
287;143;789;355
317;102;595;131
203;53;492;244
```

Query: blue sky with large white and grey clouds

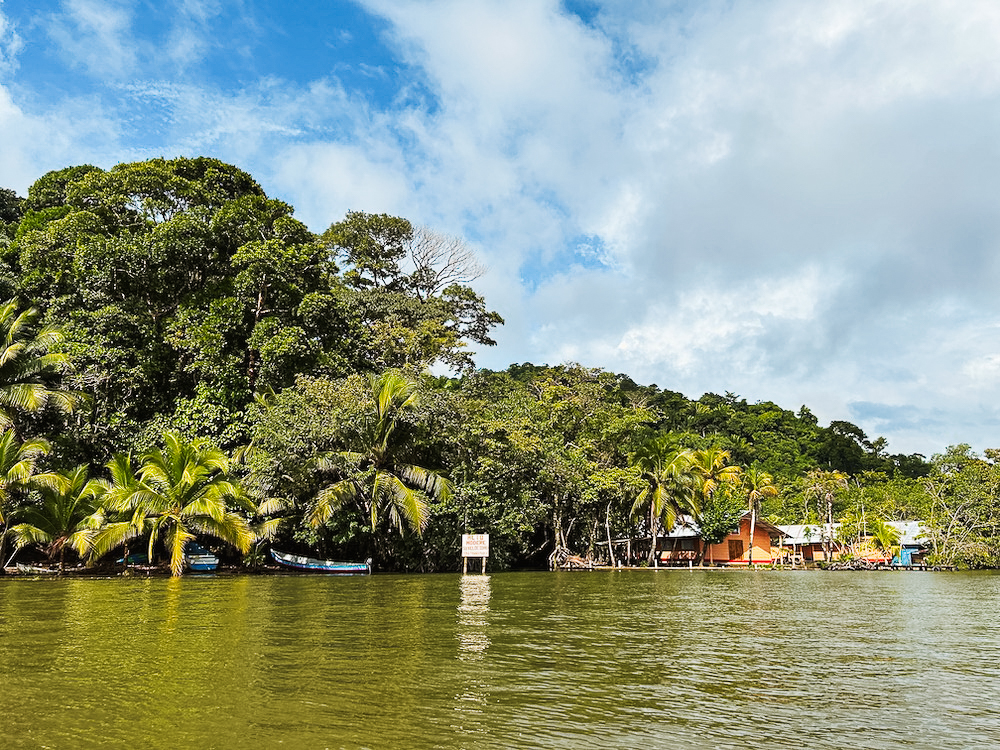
0;0;1000;456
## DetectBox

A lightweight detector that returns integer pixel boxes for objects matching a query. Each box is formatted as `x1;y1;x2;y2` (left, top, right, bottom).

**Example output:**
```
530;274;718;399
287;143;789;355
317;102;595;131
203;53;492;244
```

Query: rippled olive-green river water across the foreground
0;571;1000;750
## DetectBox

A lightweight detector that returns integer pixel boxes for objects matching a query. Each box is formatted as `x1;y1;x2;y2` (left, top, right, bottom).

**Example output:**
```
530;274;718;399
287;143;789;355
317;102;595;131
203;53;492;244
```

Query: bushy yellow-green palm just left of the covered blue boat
93;432;253;576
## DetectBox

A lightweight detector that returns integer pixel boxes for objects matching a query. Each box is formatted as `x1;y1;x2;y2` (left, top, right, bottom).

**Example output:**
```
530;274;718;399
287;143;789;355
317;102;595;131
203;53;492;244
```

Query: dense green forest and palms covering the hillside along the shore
0;158;1000;575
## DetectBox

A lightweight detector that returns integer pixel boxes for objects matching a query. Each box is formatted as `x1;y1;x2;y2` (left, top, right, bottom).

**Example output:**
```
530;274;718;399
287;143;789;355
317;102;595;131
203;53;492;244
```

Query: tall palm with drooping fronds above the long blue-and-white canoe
309;371;451;556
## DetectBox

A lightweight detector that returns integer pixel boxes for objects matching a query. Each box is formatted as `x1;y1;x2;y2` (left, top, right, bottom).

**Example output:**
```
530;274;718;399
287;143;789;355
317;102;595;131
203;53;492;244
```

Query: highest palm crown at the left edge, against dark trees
0;299;81;428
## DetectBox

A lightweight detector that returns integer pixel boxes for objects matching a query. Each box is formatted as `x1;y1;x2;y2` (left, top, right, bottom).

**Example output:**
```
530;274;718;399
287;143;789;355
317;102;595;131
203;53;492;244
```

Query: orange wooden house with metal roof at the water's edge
657;511;784;565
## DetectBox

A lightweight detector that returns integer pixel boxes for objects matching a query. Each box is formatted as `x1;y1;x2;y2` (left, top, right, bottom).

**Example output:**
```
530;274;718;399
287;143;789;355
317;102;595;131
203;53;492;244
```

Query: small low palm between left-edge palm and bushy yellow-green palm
11;466;107;573
